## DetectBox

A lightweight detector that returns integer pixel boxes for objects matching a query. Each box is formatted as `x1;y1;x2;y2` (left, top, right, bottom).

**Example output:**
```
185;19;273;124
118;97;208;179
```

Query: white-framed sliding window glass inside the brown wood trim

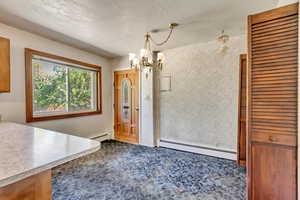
32;56;97;116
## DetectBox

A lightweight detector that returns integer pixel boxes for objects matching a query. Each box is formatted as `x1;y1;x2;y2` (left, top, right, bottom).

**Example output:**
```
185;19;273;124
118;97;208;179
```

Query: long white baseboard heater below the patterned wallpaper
159;139;237;160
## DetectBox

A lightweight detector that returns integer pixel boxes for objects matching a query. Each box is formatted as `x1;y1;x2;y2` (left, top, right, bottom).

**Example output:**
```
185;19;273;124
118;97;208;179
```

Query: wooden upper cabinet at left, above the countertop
0;37;10;92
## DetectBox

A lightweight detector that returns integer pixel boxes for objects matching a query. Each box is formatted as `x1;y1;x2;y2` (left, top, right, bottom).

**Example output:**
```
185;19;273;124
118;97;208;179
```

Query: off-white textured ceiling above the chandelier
0;0;278;57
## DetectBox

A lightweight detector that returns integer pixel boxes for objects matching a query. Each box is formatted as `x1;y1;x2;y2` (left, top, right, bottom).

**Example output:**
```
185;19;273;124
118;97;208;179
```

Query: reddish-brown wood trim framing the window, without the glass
25;48;102;122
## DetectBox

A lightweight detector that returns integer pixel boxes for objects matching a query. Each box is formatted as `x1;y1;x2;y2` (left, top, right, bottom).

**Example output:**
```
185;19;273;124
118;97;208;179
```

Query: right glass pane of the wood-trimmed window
68;68;96;111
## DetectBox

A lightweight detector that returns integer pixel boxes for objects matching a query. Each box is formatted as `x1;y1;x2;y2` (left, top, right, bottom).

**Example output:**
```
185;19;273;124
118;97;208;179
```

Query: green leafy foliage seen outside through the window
33;63;93;111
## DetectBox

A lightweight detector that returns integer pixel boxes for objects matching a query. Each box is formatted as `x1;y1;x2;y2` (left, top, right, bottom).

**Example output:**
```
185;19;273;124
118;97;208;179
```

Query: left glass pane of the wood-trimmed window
32;59;67;114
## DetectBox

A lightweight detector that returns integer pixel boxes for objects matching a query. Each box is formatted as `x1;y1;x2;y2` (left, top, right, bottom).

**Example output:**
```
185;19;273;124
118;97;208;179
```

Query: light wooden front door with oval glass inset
114;70;139;143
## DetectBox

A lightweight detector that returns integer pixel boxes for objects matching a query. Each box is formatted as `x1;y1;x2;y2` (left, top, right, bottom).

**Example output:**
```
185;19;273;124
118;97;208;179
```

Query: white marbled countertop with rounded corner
0;122;100;187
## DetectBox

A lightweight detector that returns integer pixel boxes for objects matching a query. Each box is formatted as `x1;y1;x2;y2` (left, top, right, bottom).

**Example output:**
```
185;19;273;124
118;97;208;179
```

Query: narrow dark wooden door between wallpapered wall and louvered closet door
237;54;247;166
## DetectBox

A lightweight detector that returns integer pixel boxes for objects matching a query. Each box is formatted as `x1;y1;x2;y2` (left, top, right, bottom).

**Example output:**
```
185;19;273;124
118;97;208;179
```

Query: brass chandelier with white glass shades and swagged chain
129;23;178;76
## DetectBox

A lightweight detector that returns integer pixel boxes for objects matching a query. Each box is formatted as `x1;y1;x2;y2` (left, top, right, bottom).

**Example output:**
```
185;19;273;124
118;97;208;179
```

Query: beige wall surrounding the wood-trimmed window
0;21;112;137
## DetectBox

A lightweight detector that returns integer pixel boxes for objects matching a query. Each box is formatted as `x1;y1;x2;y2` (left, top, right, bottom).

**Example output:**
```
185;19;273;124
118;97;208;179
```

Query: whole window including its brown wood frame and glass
25;49;102;122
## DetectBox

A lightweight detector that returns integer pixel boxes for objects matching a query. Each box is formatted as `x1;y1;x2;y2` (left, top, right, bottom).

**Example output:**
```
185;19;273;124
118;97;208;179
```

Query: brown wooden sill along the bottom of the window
26;111;102;123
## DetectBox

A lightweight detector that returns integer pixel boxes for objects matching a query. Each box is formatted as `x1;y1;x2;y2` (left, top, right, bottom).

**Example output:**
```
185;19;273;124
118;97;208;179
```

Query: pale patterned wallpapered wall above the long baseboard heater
160;35;246;151
